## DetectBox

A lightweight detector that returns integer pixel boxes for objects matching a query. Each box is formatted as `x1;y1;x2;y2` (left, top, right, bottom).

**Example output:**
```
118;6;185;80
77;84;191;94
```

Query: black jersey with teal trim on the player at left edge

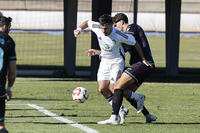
0;31;16;96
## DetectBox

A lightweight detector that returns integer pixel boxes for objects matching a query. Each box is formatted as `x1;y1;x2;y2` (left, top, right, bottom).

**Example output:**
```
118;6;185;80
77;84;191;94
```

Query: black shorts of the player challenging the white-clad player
125;61;154;86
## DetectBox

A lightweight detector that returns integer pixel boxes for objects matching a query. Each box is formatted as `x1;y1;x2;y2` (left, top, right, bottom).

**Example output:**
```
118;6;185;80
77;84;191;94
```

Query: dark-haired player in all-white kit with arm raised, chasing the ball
74;14;152;123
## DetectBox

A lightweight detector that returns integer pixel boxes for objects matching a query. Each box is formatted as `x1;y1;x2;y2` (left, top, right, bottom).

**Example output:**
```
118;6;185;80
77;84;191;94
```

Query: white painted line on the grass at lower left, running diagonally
6;104;98;133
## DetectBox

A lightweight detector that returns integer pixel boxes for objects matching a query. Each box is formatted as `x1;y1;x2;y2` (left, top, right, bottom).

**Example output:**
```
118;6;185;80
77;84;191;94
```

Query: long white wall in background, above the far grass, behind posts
3;10;200;32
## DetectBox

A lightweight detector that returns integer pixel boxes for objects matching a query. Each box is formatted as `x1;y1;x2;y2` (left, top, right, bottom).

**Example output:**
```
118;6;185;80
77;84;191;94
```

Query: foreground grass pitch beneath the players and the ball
6;78;200;133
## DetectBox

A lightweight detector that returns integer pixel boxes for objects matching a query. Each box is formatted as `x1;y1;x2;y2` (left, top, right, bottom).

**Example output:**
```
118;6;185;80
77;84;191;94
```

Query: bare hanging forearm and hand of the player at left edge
6;60;17;101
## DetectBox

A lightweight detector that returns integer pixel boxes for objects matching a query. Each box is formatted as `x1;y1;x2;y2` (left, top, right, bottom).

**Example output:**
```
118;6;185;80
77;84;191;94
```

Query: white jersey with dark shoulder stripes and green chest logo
88;21;136;60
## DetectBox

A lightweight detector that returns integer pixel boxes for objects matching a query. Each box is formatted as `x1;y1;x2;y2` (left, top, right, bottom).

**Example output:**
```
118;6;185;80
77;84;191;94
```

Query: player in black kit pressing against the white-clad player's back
99;13;157;124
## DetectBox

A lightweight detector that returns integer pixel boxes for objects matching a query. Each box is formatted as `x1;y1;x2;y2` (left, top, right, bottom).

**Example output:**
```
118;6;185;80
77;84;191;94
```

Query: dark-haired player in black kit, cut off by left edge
0;16;17;133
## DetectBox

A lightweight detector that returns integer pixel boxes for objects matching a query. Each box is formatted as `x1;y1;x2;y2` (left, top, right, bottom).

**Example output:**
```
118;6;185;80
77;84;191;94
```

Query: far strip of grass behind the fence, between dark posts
11;33;200;68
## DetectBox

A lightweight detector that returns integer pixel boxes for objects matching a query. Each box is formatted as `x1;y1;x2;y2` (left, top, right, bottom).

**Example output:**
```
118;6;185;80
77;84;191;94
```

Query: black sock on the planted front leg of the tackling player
112;89;123;115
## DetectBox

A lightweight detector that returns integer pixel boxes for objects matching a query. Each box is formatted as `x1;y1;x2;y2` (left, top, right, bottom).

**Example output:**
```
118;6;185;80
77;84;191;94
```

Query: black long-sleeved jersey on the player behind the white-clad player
125;24;154;65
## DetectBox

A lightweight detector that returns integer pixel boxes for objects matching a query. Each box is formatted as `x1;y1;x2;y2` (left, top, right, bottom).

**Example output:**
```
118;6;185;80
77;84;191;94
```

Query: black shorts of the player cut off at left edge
0;95;6;122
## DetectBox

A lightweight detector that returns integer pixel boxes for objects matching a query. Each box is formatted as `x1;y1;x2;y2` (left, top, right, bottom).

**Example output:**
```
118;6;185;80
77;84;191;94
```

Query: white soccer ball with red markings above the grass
72;87;89;103
